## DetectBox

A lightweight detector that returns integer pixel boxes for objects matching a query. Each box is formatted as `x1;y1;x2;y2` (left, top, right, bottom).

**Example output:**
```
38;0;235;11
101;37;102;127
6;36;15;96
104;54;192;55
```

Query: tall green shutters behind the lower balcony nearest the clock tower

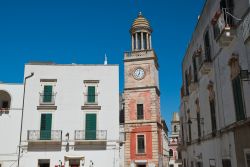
85;114;96;140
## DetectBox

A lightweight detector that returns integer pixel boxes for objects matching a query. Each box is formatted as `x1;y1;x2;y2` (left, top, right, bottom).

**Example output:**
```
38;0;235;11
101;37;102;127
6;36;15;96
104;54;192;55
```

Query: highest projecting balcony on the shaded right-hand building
212;9;236;47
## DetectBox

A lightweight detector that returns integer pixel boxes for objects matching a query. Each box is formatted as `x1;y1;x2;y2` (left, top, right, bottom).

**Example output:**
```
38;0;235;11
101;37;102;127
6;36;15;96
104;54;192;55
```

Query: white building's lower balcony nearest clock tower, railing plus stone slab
75;130;107;144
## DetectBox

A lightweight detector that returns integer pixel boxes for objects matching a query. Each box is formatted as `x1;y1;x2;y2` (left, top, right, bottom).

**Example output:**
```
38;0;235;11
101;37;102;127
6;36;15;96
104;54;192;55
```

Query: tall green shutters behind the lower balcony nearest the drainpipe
40;114;52;140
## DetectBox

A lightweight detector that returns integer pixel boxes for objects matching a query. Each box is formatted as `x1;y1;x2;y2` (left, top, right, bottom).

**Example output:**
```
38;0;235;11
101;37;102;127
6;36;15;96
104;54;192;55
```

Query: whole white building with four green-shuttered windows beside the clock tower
16;63;119;167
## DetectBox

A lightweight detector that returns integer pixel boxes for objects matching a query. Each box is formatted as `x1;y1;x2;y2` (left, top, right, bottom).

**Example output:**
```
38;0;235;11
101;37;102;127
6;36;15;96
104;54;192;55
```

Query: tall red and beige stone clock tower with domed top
124;13;163;167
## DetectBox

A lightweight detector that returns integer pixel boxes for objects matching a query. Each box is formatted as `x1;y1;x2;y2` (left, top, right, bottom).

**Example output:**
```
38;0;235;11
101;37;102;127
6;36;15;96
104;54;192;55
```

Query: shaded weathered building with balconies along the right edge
180;0;250;167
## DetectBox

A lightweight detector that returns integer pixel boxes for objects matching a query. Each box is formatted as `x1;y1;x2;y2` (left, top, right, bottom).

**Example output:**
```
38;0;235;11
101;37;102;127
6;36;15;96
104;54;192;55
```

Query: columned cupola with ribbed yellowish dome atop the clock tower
130;12;152;51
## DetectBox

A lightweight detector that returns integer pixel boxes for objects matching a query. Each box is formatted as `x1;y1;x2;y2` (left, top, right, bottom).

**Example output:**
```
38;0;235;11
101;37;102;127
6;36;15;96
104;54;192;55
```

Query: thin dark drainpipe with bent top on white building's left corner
17;72;34;167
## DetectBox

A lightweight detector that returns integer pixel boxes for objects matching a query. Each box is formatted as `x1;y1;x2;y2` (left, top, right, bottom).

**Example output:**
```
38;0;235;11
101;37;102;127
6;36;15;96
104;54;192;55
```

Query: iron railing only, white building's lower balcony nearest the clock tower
75;130;107;141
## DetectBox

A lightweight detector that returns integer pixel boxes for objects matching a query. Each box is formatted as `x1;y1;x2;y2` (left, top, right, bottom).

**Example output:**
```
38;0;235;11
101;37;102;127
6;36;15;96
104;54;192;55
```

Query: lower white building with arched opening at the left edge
0;83;23;167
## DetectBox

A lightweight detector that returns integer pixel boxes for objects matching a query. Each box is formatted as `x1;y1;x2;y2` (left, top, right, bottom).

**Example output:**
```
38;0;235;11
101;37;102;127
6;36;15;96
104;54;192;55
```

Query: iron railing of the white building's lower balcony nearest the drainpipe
28;130;62;142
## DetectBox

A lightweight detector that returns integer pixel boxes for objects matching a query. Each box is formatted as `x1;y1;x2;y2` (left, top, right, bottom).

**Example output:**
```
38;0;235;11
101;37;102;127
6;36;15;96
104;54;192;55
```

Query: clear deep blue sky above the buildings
0;0;204;126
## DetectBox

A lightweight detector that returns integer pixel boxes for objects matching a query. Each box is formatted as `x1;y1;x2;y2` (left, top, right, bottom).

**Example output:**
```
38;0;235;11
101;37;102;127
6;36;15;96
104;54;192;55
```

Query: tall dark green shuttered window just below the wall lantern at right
232;75;246;121
